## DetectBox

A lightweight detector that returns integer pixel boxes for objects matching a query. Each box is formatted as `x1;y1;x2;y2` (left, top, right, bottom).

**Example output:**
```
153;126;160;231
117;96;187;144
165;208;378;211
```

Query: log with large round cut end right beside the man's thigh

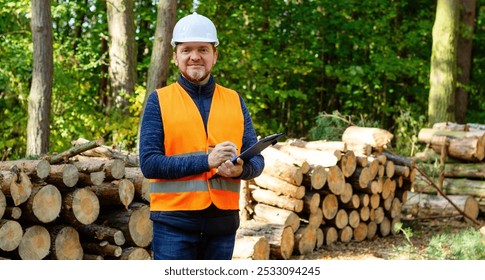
98;202;153;248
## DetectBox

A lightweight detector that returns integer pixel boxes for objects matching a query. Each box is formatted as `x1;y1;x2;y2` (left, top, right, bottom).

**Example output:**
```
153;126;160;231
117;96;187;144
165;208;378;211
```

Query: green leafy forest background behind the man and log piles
0;0;485;160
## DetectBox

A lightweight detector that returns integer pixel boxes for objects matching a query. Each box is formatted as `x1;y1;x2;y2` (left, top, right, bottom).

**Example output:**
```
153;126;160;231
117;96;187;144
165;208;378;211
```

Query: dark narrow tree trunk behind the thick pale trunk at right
455;0;477;123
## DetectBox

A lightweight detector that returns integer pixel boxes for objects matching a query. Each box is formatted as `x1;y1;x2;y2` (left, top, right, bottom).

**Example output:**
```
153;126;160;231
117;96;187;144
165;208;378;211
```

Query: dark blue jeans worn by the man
152;213;239;260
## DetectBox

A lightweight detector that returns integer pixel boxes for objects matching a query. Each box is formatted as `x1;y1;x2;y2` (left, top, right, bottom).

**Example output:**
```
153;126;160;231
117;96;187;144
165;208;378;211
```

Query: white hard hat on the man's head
171;12;219;47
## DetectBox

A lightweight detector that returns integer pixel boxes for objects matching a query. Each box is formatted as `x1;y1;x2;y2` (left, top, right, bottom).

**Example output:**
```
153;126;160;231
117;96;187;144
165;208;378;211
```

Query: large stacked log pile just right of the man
233;127;416;259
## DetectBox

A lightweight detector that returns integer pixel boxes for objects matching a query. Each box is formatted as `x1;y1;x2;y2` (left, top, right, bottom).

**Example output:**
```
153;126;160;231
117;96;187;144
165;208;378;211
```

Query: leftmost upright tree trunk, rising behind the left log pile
26;0;54;156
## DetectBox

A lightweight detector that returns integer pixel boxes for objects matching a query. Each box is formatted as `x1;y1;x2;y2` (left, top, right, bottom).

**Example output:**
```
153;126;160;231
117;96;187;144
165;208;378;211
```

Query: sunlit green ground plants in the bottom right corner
426;228;485;260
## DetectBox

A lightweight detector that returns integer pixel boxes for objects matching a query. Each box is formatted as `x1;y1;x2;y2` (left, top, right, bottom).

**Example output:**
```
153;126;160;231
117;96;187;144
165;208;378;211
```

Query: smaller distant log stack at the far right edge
413;123;485;217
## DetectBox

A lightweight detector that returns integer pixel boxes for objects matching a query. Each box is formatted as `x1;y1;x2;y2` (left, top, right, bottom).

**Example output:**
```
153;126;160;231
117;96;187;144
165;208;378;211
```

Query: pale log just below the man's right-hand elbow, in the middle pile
254;173;305;199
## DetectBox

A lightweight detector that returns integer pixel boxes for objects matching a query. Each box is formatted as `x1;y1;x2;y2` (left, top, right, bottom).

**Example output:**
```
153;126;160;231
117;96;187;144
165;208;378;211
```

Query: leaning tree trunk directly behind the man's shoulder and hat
137;0;177;150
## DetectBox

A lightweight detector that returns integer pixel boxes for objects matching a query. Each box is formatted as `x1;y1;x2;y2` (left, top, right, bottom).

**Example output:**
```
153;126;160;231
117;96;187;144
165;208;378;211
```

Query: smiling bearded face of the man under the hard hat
173;42;218;84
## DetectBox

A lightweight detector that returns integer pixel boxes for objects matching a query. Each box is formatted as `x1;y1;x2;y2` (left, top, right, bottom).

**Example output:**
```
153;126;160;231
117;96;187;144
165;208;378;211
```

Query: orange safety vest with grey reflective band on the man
150;83;244;211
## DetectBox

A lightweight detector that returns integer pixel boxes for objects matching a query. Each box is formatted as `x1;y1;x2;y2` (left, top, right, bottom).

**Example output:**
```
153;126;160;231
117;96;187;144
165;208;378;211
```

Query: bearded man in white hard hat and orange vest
139;13;264;260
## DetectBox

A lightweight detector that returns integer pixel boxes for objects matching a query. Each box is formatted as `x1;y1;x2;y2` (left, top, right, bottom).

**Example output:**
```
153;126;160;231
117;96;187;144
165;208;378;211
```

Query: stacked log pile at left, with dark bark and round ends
0;140;152;260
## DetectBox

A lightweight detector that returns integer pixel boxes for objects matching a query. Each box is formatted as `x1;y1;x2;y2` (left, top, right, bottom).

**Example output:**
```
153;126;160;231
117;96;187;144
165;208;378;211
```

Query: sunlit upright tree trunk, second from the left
106;0;136;110
